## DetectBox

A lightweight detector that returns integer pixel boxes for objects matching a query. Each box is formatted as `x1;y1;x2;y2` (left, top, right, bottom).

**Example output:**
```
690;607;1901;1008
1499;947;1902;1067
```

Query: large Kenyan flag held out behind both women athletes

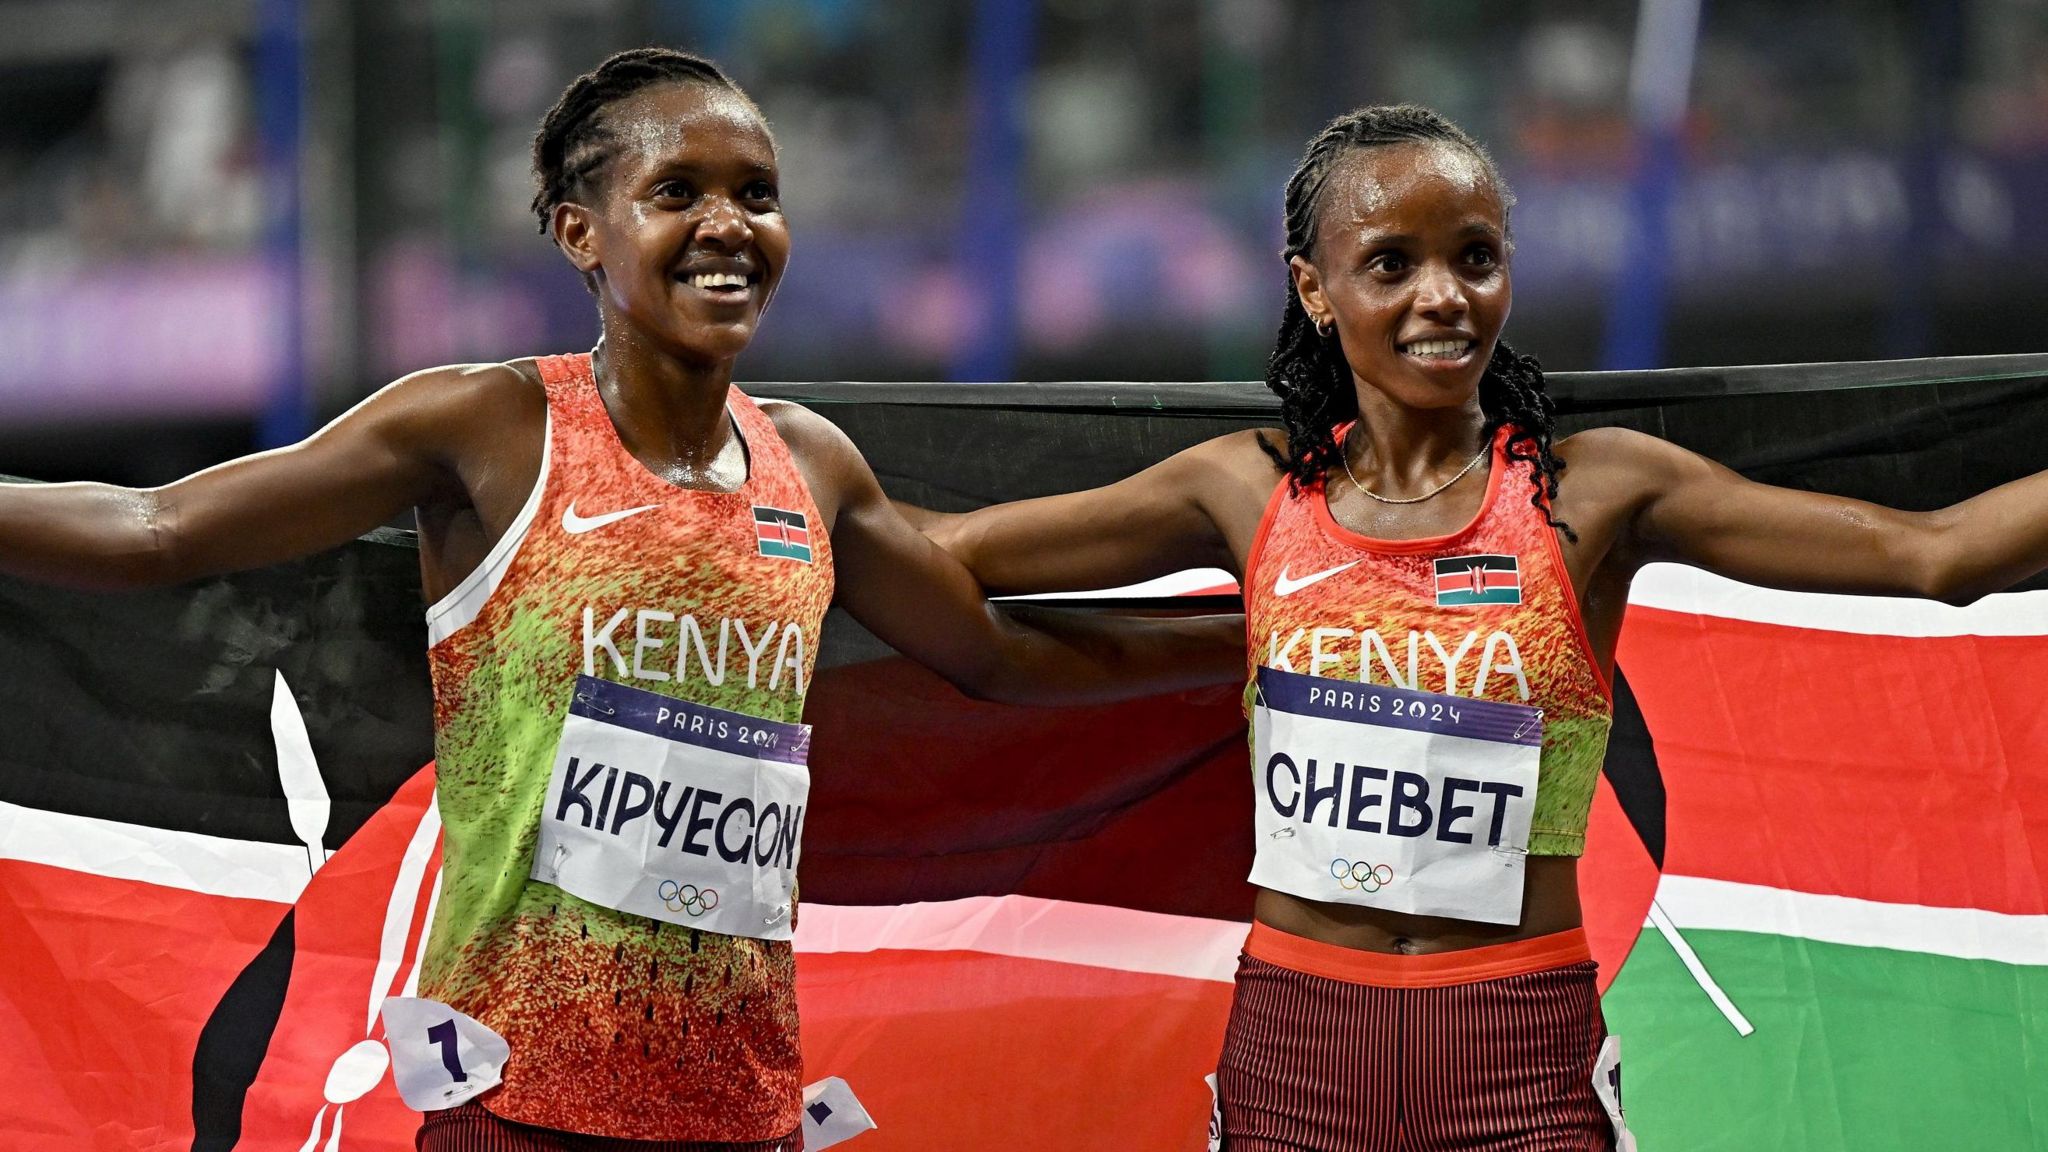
0;359;2048;1152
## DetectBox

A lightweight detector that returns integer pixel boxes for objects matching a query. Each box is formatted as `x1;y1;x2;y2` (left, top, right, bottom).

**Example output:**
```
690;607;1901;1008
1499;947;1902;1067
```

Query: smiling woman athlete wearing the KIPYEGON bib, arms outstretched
0;49;1239;1152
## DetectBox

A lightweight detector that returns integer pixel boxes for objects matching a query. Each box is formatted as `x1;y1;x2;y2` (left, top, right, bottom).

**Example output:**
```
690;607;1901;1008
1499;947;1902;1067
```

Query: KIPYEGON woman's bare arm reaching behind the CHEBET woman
780;412;1245;703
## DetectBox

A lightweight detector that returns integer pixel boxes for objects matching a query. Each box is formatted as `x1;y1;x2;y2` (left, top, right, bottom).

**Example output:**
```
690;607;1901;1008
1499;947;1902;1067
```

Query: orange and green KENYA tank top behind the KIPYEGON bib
420;355;834;1142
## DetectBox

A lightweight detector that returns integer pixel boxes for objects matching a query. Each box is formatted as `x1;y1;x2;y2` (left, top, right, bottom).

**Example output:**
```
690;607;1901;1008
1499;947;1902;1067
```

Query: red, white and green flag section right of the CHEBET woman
1589;566;2048;1150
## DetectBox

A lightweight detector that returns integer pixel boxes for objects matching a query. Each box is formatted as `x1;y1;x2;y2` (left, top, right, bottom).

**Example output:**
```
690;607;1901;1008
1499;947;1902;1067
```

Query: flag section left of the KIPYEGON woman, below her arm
0;533;440;1152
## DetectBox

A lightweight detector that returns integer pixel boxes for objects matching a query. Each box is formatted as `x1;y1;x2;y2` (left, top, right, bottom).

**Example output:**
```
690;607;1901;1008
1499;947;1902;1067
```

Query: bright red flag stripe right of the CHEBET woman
1620;607;2048;914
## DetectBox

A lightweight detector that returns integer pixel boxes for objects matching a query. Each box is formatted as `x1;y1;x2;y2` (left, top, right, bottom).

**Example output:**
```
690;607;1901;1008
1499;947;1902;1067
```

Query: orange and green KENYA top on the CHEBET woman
1243;426;1614;857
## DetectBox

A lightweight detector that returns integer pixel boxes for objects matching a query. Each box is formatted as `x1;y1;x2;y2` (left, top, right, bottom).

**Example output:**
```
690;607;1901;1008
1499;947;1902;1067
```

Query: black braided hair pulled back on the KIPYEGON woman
532;47;758;236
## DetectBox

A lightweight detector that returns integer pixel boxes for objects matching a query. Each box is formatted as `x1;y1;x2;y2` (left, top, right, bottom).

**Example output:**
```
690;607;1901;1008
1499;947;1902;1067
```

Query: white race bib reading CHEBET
1251;668;1542;924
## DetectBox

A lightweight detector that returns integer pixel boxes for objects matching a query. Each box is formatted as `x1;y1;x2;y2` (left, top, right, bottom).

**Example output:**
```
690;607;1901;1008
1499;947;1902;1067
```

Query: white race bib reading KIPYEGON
530;676;811;941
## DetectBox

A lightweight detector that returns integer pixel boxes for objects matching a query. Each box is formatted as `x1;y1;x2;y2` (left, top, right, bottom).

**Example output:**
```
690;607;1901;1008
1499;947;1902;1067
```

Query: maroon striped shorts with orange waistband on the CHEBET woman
1217;922;1614;1152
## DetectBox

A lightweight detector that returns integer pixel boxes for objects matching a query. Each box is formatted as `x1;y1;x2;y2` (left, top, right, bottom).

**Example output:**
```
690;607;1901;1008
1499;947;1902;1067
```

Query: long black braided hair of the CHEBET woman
1262;105;1579;541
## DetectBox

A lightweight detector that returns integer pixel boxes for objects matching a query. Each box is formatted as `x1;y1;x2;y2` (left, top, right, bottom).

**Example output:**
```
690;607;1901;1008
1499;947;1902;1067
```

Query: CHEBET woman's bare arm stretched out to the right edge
1567;428;2048;603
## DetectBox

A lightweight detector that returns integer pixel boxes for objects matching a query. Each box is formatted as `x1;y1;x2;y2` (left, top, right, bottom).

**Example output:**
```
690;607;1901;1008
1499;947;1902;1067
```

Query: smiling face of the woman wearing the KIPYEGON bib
553;82;788;361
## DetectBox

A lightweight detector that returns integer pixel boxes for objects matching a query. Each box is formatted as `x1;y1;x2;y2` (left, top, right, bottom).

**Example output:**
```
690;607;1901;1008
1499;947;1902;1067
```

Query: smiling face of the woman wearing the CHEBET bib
1290;143;1513;408
